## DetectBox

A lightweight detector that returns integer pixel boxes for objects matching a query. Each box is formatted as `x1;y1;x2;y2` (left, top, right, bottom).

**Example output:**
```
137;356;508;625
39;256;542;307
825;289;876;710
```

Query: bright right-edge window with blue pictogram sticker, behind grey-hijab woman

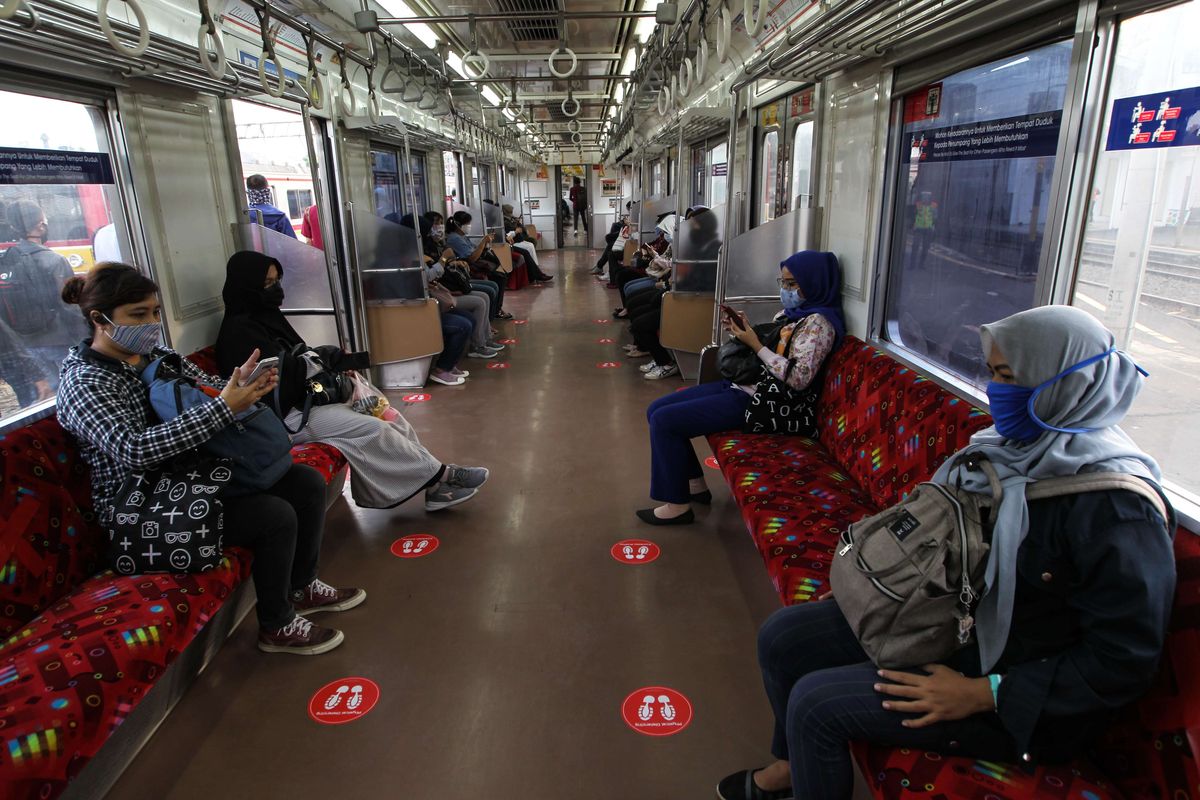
1073;4;1200;498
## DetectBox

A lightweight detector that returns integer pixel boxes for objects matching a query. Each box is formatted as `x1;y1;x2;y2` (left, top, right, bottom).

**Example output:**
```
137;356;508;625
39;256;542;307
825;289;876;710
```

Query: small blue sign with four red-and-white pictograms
1105;86;1200;150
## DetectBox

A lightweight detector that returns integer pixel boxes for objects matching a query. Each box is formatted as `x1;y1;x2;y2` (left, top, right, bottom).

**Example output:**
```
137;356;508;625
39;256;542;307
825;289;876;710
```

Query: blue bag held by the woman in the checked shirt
142;353;292;495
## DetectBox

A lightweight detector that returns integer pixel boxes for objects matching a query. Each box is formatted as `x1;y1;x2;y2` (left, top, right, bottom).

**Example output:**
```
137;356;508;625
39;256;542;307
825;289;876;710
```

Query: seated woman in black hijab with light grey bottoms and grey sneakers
216;251;487;511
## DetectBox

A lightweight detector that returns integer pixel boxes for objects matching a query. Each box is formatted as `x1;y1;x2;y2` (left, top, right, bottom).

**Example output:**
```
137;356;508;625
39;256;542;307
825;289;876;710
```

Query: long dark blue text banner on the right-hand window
904;109;1062;164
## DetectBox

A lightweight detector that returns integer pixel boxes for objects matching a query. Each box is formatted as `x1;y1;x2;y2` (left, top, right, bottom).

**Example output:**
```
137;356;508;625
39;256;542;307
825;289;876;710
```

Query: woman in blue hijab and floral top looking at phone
637;251;846;525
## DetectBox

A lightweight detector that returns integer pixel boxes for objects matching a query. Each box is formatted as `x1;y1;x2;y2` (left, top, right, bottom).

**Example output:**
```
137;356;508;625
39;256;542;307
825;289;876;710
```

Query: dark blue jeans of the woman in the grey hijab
758;600;1016;800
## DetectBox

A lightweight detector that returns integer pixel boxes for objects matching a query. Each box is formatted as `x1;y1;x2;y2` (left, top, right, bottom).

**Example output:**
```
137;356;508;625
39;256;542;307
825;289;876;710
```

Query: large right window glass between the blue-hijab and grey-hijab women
887;42;1070;385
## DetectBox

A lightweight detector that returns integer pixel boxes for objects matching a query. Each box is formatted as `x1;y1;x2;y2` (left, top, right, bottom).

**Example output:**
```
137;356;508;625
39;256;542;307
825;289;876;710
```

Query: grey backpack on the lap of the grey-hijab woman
829;453;1170;669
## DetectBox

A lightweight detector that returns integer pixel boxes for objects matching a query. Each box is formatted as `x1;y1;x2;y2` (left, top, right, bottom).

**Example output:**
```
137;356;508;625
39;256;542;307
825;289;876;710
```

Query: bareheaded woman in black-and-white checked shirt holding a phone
58;264;366;655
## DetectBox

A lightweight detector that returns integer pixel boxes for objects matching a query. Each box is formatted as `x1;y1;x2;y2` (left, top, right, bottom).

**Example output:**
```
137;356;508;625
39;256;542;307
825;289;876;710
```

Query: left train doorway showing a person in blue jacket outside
230;100;345;344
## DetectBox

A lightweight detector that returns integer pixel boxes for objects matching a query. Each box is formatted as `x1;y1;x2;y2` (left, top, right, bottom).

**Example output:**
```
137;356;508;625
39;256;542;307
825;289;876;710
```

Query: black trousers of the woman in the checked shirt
223;464;325;630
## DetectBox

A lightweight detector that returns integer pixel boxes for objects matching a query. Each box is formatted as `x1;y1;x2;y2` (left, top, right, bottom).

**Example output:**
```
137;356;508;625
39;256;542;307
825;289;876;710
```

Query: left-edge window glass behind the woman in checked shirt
0;91;132;419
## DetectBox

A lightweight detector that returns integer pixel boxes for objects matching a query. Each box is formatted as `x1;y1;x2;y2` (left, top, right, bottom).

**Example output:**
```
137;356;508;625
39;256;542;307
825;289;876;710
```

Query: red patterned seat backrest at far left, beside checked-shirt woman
0;417;106;637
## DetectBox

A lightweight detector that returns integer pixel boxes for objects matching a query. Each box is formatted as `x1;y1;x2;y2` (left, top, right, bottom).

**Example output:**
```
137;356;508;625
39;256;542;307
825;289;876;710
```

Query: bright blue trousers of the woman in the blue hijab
646;380;750;503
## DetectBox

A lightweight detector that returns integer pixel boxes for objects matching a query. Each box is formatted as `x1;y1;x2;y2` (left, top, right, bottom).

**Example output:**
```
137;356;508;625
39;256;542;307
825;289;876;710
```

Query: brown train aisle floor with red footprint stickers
109;251;778;800
